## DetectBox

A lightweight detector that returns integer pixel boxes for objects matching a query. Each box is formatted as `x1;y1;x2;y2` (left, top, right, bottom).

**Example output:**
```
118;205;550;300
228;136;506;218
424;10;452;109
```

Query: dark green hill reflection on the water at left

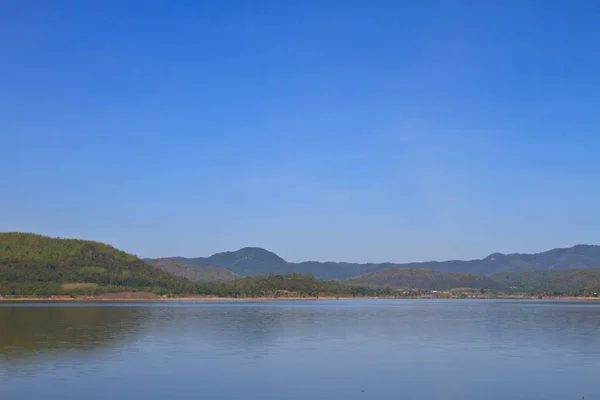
0;304;142;376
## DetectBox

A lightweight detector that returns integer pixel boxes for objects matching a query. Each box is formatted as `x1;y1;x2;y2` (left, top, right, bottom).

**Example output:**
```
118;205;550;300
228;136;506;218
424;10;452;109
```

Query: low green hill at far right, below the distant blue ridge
491;269;600;293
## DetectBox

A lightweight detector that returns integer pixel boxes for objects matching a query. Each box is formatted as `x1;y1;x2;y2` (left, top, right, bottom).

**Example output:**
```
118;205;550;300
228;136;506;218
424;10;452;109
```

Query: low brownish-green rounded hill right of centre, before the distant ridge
346;268;509;291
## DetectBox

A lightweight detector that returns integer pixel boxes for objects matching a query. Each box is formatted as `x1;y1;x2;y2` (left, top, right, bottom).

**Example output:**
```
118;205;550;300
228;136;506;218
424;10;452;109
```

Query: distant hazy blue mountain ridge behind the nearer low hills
155;245;600;280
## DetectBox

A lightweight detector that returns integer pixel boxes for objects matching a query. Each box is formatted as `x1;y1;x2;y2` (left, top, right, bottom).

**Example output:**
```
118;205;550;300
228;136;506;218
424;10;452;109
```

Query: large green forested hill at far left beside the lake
0;233;194;295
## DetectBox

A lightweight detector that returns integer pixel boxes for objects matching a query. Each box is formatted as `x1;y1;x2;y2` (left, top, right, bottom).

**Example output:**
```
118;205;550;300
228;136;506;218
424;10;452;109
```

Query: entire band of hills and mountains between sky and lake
0;232;600;297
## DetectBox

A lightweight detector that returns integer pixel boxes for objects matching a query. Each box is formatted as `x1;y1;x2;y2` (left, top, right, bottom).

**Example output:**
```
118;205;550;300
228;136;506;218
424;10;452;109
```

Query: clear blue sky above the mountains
0;0;600;262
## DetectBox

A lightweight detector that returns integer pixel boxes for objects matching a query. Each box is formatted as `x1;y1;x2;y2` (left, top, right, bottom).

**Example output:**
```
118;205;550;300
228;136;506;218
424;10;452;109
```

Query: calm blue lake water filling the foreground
0;300;600;400
